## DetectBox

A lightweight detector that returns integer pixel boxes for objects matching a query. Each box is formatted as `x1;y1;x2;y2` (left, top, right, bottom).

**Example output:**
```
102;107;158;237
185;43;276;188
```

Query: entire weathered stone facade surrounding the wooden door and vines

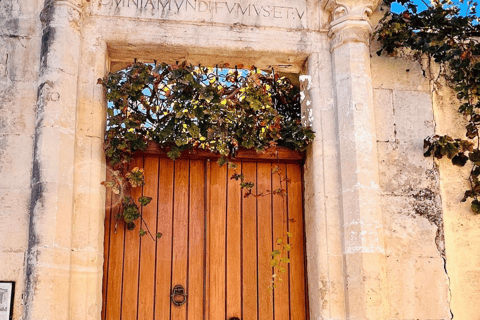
0;0;480;320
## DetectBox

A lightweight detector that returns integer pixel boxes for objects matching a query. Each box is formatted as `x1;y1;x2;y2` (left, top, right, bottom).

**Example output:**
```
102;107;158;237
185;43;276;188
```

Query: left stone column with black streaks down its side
22;0;81;320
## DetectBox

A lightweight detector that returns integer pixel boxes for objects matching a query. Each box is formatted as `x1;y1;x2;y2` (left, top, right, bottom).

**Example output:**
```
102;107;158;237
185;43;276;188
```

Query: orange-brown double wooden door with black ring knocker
102;151;308;320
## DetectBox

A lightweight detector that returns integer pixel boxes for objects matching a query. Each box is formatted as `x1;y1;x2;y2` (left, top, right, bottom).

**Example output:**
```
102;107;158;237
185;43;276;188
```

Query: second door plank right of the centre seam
226;163;242;319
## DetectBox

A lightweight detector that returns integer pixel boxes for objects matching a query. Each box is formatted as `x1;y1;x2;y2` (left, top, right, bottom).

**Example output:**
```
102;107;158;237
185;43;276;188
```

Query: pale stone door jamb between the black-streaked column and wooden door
70;27;108;320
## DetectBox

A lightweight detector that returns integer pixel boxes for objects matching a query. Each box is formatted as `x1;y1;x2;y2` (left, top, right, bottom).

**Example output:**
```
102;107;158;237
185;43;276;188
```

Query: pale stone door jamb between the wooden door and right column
301;38;345;319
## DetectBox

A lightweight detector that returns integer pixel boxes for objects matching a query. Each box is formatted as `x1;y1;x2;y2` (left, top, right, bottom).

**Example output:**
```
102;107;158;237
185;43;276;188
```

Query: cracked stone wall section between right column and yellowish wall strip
371;10;452;320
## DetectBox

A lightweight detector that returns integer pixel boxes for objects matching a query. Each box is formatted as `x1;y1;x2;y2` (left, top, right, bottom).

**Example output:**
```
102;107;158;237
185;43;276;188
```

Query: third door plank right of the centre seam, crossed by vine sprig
240;162;258;320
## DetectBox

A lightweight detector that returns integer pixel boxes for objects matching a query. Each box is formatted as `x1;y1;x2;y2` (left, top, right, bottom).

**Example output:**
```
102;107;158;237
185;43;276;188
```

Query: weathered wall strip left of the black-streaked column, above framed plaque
0;0;43;319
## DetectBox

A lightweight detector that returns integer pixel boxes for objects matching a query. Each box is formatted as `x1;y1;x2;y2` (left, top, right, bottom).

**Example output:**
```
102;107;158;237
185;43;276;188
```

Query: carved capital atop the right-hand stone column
320;0;380;51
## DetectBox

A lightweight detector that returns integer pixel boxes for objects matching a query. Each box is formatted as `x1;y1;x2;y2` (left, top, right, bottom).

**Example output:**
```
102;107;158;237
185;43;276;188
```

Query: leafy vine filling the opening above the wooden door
98;62;314;238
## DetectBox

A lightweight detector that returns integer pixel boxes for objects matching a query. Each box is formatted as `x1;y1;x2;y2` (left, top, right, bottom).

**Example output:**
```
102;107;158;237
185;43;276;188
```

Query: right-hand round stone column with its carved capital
323;0;388;319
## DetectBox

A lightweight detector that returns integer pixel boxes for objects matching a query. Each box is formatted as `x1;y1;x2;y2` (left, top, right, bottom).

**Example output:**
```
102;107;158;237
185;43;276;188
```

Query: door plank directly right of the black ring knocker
187;160;205;320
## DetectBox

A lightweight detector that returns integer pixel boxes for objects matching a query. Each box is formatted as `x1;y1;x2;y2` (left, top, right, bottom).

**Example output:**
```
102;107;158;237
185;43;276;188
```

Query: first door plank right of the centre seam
208;163;228;320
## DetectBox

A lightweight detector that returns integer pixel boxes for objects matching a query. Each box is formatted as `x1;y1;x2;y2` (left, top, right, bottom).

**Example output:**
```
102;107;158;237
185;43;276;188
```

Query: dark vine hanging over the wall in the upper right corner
375;0;480;214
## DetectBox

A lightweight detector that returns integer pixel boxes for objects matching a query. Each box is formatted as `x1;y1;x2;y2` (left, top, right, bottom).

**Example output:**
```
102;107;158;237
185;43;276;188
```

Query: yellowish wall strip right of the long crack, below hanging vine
433;64;480;319
